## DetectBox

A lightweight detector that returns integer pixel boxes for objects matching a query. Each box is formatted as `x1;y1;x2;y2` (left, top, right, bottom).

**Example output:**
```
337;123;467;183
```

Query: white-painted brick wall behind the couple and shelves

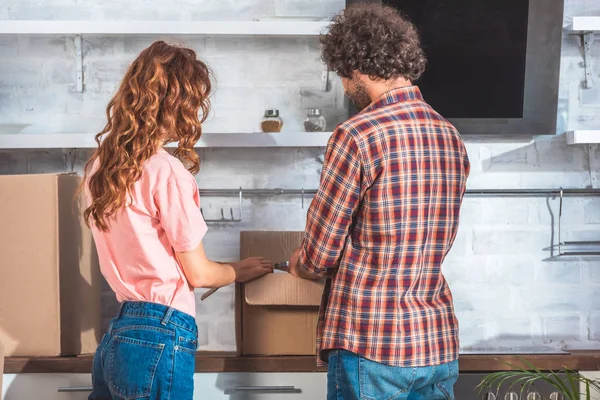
0;0;600;350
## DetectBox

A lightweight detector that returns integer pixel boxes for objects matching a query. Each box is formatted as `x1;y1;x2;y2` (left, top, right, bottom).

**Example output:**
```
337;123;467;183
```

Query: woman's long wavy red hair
82;41;211;231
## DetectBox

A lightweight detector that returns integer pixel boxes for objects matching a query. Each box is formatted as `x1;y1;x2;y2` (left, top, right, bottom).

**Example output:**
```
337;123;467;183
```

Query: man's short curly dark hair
321;3;427;81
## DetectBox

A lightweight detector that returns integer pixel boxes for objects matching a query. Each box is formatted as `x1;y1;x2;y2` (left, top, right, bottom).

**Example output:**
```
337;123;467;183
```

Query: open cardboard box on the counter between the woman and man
236;232;323;355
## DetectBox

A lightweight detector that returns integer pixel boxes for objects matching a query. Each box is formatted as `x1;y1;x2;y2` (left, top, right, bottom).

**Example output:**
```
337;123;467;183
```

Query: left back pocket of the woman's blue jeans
105;336;165;400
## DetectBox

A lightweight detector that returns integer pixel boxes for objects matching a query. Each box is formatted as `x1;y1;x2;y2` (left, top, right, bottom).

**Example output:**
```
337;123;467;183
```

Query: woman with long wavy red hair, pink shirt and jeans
82;41;272;400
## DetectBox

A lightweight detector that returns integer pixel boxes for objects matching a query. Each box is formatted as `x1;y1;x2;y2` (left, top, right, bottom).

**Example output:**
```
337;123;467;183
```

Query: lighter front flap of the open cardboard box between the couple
244;273;324;307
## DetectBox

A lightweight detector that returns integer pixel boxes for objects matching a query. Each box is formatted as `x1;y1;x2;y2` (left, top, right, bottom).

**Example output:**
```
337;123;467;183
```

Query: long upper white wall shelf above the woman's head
0;20;329;36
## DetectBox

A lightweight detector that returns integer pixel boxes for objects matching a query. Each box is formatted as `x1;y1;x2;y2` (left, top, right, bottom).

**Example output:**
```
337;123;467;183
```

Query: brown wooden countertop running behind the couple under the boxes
4;350;600;374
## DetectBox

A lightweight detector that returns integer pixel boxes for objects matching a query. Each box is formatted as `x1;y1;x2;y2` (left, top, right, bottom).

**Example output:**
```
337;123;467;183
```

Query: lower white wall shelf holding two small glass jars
0;132;331;150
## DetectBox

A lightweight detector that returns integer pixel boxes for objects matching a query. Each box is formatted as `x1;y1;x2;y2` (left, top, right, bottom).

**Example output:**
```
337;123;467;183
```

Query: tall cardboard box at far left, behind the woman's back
0;174;102;356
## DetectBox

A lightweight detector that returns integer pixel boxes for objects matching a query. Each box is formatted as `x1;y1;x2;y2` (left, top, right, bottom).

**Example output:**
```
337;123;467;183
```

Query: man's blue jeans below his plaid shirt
327;350;458;400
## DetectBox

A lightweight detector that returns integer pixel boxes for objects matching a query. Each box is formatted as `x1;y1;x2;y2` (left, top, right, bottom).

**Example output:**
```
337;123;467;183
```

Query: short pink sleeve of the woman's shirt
154;179;208;253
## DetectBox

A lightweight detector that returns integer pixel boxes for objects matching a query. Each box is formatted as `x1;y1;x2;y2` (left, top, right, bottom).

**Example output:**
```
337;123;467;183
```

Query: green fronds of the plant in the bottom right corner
477;360;600;400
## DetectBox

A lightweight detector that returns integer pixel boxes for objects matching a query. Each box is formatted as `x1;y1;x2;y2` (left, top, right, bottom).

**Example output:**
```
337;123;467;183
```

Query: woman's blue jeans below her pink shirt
89;302;198;400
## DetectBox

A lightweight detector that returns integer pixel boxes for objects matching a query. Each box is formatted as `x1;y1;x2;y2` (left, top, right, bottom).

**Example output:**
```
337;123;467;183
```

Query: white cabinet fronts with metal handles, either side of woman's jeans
2;373;327;400
